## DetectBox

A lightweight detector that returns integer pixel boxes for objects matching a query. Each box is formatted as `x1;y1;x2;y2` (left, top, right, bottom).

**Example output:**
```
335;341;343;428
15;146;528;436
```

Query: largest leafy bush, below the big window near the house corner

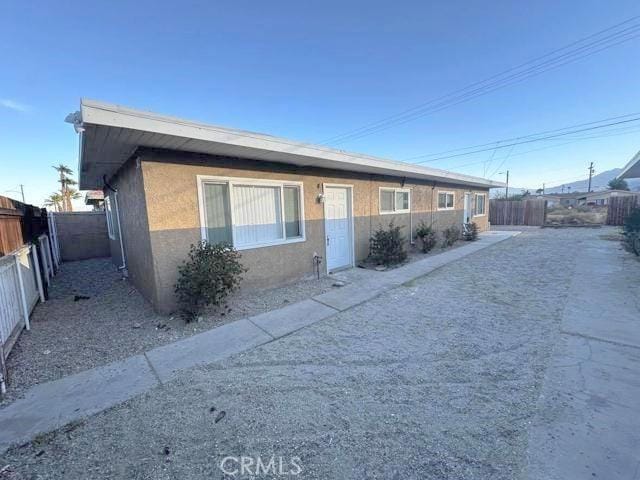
175;241;247;321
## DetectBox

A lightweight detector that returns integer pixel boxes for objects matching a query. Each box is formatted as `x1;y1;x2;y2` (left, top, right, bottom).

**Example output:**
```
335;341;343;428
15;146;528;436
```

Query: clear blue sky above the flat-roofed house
0;0;640;204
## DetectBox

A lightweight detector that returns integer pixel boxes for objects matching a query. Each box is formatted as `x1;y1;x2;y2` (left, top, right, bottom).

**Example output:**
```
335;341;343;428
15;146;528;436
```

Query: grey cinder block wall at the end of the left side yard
54;212;110;262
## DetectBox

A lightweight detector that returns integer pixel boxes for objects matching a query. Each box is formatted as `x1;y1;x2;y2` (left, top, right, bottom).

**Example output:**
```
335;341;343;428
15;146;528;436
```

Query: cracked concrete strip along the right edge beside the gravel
528;232;640;480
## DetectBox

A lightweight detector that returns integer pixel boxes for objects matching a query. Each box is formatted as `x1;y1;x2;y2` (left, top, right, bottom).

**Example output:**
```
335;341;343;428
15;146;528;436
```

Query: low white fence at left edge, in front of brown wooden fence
0;240;47;393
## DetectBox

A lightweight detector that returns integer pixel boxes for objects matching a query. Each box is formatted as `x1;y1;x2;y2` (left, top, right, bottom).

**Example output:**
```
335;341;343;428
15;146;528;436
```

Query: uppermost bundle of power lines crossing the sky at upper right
322;16;640;144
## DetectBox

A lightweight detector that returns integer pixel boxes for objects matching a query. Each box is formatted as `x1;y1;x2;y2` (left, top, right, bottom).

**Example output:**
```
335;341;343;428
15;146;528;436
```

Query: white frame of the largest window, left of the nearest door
196;175;307;250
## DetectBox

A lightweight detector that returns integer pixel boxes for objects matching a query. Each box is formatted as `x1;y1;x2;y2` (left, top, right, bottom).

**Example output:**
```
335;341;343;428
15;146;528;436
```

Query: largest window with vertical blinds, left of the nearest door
201;177;304;249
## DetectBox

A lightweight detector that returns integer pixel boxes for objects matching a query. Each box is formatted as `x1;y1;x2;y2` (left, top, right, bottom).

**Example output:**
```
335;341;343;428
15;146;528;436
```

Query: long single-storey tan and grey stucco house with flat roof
67;100;504;312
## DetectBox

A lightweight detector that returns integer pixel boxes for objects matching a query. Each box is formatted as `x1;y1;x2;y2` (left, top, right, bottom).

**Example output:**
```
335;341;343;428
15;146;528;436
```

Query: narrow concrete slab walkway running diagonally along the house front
0;231;519;453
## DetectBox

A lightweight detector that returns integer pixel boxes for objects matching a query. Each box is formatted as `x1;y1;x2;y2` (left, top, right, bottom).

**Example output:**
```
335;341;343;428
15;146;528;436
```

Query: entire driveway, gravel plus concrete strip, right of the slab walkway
0;229;640;480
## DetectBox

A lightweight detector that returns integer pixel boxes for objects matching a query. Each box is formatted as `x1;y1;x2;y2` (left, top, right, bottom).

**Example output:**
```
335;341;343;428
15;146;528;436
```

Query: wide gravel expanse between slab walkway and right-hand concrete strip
1;229;604;480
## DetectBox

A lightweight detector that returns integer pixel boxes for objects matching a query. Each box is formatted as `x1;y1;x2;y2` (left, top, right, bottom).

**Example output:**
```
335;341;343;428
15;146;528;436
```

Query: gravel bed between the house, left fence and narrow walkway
0;259;344;408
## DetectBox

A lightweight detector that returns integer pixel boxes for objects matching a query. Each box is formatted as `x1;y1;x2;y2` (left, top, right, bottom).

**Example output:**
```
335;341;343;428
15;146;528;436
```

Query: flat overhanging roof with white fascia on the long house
66;99;505;190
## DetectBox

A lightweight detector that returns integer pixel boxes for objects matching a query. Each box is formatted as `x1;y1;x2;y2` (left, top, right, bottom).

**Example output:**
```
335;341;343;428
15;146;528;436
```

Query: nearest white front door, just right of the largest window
324;187;353;272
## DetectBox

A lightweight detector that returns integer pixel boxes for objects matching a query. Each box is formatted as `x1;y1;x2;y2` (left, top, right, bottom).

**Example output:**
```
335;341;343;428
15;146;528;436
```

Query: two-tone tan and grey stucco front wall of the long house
138;151;489;312
